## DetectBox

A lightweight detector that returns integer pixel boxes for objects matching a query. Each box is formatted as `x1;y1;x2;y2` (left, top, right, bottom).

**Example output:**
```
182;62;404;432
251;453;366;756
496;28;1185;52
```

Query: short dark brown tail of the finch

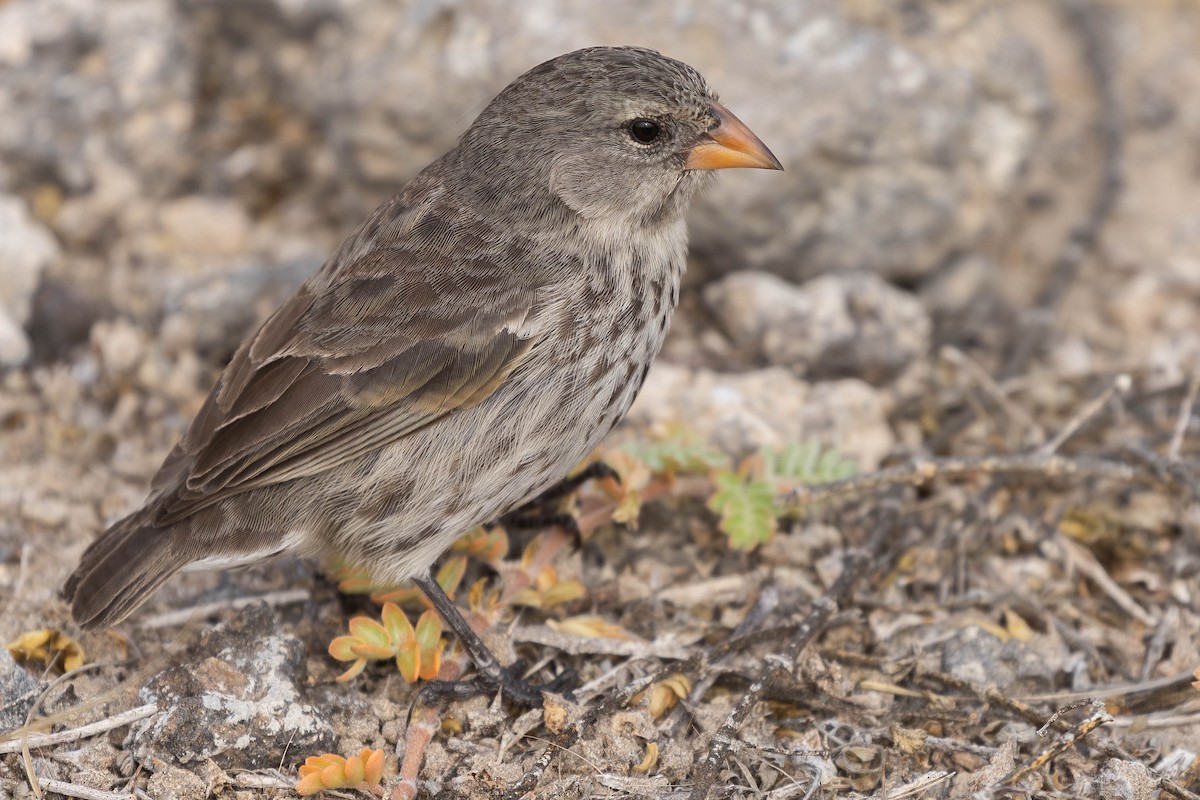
62;513;191;630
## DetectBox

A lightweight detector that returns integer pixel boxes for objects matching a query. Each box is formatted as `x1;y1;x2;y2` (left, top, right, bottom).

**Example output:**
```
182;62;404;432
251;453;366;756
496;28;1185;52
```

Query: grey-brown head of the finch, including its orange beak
446;47;782;232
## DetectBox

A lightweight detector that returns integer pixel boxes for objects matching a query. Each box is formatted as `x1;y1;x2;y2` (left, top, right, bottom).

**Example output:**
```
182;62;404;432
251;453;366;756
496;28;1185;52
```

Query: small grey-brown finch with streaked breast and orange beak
64;47;781;700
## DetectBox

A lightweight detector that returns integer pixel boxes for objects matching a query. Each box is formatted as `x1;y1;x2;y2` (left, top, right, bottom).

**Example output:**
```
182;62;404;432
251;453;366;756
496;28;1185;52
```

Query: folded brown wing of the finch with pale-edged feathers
147;248;539;525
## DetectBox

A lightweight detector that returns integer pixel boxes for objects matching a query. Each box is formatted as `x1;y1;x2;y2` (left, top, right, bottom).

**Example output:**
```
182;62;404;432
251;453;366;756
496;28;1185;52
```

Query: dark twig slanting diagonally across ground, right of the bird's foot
689;513;895;800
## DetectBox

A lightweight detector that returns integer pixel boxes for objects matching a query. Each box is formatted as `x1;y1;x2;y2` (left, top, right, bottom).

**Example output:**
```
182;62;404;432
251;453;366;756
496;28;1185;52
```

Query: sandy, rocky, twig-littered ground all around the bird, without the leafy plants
0;0;1200;800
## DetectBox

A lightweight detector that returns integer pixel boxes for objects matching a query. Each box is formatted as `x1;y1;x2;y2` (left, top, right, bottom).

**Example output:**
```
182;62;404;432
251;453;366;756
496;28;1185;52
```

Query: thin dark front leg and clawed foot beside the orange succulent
413;573;575;709
